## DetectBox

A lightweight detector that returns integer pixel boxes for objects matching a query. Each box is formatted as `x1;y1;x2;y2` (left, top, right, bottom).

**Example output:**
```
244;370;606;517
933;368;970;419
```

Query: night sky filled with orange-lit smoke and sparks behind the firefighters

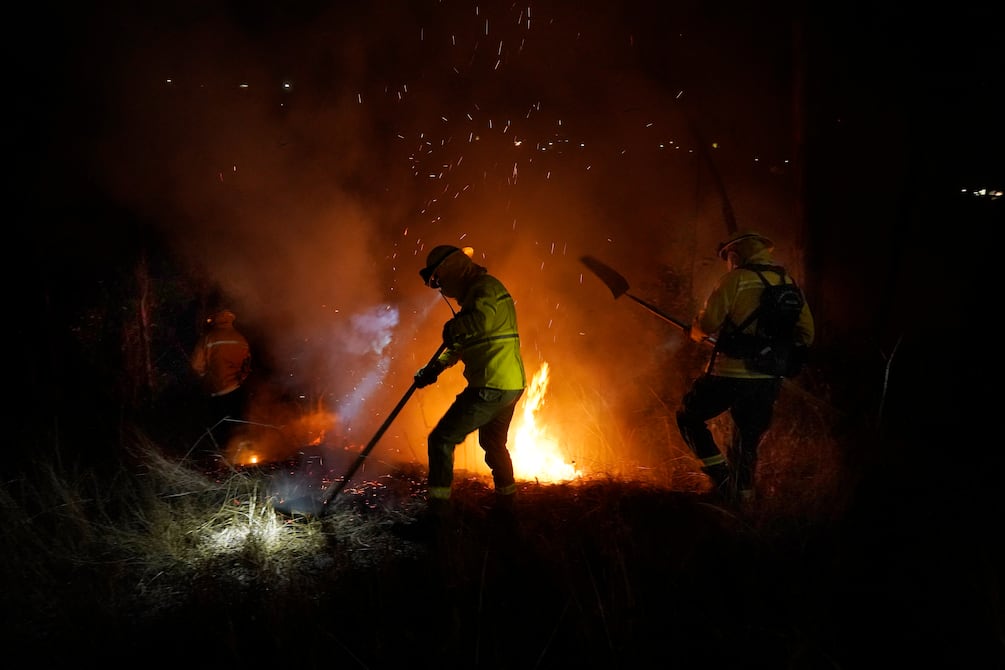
5;0;1005;476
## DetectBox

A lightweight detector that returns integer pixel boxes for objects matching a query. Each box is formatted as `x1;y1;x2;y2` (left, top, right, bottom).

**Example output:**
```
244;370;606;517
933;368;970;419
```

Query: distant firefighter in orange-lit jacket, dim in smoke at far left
190;309;251;454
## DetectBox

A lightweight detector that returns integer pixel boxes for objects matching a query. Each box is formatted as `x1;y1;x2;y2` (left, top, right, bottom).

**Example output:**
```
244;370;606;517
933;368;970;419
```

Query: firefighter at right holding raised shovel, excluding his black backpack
676;231;814;502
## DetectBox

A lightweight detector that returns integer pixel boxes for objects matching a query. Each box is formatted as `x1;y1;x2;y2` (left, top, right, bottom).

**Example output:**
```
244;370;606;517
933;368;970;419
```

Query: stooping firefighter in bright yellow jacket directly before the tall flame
415;245;527;515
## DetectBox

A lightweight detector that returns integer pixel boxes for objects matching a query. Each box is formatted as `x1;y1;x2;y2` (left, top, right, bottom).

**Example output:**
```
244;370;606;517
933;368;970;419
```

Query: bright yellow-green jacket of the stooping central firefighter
439;273;527;391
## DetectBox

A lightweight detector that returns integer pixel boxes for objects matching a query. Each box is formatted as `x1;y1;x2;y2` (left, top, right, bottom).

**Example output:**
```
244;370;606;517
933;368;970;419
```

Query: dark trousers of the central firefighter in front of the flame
428;388;524;498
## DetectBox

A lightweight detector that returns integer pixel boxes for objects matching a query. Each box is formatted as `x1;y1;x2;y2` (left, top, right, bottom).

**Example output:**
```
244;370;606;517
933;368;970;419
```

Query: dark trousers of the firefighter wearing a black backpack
677;375;782;490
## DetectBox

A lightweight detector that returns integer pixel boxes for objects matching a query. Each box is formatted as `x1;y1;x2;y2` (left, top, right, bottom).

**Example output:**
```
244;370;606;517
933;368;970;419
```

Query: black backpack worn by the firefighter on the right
716;264;806;377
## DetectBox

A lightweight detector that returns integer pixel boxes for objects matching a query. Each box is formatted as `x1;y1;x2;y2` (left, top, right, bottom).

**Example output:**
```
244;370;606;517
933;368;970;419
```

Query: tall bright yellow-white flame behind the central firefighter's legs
510;362;582;482
